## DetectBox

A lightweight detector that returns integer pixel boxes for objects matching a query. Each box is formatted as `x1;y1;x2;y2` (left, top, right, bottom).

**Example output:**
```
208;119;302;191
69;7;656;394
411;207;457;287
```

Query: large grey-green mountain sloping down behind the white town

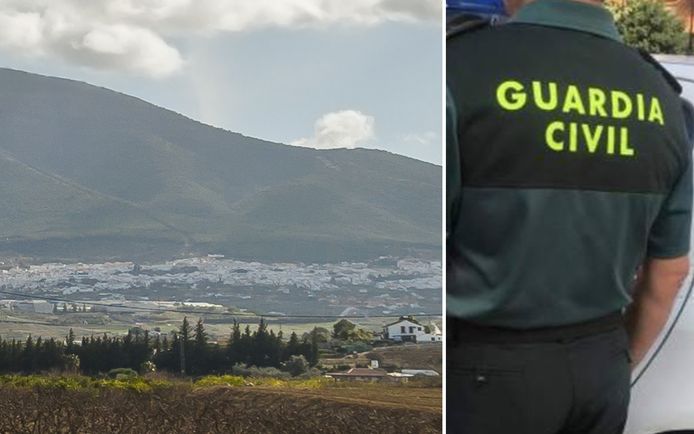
0;69;441;261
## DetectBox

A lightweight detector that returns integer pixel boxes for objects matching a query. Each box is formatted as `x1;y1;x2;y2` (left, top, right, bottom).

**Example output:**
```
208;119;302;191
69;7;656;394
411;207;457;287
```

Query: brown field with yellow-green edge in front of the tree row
0;376;442;434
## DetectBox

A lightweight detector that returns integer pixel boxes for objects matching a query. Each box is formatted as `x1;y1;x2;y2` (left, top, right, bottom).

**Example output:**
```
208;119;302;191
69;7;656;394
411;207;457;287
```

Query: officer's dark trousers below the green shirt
446;320;630;434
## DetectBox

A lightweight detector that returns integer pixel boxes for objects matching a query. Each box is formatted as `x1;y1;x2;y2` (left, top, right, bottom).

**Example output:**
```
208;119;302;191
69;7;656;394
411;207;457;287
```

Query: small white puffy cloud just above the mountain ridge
291;110;375;149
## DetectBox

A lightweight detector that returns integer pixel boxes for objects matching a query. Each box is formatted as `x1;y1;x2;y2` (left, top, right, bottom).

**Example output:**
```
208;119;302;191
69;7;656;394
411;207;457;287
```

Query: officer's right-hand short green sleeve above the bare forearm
646;102;694;259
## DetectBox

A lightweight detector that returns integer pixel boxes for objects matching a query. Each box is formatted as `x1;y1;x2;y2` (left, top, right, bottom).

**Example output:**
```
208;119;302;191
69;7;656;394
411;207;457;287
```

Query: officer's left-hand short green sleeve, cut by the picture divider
446;89;462;238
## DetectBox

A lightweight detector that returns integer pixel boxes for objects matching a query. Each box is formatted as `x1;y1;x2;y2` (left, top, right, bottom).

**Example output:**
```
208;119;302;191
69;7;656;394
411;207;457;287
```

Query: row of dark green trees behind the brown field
0;318;320;375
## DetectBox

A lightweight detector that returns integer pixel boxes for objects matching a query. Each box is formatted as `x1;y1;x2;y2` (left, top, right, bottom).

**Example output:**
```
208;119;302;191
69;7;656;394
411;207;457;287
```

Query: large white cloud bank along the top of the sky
0;0;442;77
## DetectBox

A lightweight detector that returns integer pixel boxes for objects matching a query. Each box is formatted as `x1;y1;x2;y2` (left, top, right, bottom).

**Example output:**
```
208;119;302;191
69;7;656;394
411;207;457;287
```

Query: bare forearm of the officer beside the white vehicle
626;256;689;367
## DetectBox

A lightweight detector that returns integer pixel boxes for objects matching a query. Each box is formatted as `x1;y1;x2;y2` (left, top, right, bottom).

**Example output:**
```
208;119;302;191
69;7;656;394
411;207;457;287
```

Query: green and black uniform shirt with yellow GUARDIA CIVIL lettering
446;0;692;328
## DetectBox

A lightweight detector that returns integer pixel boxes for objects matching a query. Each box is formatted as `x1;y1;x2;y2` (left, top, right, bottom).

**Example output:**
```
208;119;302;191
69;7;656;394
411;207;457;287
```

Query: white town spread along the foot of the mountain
0;255;441;318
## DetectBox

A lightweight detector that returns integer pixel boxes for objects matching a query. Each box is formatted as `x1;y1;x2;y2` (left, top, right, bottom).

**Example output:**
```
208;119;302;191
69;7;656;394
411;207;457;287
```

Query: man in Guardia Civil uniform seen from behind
446;0;692;434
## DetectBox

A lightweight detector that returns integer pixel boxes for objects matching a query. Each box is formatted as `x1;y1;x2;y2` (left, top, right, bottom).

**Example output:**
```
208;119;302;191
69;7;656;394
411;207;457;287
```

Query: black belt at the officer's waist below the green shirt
446;311;624;343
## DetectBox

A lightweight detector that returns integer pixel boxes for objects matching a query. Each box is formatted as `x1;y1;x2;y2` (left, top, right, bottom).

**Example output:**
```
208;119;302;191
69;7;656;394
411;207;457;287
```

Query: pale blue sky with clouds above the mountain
0;0;442;164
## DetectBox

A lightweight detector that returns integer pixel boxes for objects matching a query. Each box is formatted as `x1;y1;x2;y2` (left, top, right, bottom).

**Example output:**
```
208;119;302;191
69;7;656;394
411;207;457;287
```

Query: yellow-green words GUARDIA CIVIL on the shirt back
496;80;665;157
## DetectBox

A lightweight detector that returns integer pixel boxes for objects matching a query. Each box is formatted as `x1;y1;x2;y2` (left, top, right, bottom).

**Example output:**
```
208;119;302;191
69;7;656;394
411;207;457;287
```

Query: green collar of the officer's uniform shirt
511;0;622;41
